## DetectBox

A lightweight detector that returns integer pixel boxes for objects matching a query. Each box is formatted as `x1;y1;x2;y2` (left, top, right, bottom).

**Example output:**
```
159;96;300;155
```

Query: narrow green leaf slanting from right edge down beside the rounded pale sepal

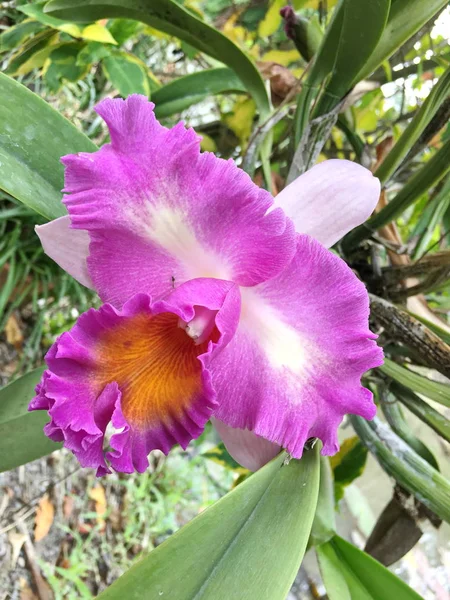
343;138;450;252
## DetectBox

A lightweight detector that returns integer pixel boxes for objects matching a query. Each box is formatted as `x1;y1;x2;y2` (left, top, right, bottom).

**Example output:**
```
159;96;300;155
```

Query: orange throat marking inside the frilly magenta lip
94;313;208;428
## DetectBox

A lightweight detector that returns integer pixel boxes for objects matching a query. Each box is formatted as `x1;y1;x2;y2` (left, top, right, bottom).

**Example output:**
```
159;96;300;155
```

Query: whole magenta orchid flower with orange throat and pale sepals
30;95;382;475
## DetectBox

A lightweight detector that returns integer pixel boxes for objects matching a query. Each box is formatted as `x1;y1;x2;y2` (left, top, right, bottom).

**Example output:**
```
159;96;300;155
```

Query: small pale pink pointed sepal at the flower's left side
35;215;94;288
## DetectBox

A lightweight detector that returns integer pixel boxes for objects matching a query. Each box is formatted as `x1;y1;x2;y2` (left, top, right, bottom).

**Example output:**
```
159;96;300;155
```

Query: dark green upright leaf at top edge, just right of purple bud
314;0;391;117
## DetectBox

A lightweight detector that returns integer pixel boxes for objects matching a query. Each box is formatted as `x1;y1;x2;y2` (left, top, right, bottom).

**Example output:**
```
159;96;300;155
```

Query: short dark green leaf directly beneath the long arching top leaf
152;68;246;119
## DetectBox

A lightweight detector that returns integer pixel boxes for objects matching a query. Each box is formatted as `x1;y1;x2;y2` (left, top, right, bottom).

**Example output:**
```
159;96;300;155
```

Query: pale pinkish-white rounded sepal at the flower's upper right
275;159;380;248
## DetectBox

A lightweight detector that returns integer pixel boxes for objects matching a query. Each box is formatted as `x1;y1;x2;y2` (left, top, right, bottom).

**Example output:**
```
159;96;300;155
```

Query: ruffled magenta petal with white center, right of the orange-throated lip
212;235;383;458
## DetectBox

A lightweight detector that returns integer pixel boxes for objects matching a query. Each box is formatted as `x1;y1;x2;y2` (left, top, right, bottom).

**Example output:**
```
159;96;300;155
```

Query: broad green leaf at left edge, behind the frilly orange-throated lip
0;368;61;472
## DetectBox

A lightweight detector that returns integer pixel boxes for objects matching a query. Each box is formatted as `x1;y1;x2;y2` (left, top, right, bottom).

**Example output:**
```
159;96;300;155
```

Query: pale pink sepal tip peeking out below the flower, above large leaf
211;418;281;471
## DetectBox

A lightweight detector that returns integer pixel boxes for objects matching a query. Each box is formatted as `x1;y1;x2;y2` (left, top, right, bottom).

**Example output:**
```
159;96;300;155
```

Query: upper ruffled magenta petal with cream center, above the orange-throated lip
63;95;295;307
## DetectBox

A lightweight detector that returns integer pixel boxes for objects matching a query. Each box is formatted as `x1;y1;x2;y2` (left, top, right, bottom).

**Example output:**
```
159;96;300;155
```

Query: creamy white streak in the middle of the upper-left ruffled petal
126;202;231;279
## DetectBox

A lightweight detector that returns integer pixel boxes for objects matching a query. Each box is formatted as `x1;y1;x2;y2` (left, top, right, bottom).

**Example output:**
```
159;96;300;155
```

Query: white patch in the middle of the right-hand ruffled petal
241;288;312;376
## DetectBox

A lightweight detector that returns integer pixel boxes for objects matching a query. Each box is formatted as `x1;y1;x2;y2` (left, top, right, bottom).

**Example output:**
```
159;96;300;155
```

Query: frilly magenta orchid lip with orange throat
30;279;240;475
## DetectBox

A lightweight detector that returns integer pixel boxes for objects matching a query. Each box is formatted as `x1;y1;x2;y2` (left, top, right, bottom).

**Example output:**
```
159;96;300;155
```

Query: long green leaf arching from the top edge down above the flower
45;0;270;118
